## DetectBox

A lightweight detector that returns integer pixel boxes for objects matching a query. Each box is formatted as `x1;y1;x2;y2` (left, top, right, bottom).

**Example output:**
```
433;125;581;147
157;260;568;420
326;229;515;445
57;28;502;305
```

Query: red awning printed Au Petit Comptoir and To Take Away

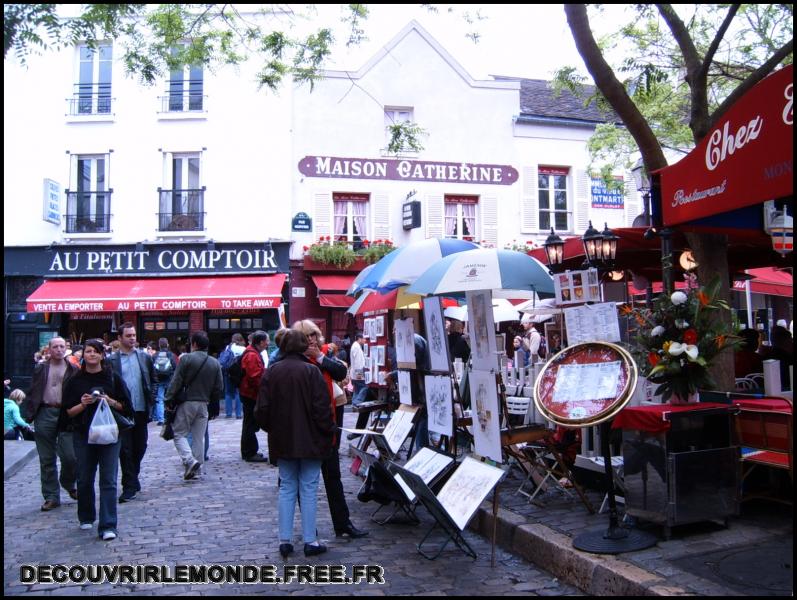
27;274;285;312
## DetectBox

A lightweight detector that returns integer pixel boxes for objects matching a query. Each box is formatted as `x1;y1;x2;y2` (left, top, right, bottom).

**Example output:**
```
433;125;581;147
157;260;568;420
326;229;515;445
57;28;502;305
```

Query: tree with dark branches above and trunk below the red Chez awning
565;4;794;390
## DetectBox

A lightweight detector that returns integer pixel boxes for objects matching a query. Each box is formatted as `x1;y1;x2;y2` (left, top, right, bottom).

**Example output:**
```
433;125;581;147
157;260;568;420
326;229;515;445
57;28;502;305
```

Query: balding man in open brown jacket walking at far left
22;337;78;511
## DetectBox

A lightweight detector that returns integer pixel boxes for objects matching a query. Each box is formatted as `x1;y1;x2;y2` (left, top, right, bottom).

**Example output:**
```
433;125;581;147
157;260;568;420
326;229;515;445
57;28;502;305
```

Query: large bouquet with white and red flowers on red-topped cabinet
622;274;740;403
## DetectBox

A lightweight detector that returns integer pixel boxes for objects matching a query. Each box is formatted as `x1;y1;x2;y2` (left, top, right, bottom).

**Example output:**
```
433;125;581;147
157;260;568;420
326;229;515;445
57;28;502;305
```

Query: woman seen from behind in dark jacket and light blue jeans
257;330;335;558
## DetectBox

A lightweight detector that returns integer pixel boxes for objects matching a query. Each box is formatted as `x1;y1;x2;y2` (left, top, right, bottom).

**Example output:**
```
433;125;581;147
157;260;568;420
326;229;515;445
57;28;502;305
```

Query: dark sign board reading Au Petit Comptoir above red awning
5;242;290;278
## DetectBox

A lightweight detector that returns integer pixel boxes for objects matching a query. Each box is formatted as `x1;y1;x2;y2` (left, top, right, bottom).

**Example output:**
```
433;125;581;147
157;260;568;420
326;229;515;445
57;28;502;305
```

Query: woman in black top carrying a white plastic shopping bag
61;339;133;541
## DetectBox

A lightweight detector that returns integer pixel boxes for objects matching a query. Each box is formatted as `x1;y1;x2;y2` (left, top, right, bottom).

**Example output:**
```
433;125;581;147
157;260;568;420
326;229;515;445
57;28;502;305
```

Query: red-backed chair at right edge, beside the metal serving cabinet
734;408;794;506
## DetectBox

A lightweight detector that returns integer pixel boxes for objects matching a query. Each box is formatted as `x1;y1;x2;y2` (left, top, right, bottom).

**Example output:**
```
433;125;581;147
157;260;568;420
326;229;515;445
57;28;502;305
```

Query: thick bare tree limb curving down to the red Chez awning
564;4;667;172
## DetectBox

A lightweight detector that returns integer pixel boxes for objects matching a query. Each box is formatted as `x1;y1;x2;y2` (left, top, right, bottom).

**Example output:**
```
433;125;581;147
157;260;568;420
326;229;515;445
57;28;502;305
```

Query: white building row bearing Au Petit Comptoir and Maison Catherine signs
4;22;640;384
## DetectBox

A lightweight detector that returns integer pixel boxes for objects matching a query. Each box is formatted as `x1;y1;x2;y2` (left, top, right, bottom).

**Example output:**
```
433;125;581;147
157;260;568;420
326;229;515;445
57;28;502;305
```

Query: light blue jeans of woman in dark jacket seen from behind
279;458;321;544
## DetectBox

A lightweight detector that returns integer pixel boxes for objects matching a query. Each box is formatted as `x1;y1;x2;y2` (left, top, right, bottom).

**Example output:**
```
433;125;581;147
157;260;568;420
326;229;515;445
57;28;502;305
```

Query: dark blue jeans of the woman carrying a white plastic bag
72;431;122;535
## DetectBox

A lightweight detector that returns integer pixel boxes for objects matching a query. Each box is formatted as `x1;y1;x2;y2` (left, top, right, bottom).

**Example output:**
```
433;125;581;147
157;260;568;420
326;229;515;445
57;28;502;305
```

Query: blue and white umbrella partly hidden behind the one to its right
348;238;479;296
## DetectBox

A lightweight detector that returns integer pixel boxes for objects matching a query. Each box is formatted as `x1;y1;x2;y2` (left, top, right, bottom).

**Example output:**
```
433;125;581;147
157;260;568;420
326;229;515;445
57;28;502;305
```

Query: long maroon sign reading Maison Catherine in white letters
299;156;518;185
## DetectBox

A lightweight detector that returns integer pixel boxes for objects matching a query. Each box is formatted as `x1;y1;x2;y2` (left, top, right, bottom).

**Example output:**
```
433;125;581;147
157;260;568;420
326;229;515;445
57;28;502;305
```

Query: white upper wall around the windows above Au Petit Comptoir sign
4;41;291;246
